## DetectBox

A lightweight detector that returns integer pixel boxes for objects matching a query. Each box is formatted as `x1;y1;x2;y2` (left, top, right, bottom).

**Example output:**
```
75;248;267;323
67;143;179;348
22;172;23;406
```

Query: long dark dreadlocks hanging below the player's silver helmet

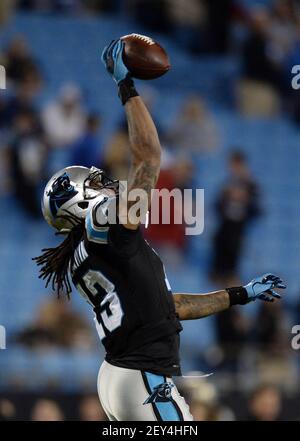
32;210;84;298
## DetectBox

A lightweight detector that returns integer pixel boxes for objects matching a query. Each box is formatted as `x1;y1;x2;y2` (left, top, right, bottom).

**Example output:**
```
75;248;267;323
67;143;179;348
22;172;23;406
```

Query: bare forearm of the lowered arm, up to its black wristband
174;291;230;320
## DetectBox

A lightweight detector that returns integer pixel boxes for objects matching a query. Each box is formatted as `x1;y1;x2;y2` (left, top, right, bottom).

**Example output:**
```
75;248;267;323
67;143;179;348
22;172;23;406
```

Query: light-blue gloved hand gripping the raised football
101;40;130;84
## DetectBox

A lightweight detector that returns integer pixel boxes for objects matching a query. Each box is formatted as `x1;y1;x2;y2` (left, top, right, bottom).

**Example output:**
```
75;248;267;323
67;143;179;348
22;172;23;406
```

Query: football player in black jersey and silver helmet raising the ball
35;40;285;421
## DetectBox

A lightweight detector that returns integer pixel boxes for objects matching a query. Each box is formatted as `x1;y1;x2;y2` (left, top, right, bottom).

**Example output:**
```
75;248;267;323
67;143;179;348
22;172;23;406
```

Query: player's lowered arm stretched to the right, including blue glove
174;273;286;320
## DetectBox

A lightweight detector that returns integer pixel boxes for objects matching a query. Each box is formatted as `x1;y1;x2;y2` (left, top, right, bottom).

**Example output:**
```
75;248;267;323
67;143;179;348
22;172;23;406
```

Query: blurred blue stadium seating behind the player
0;15;300;387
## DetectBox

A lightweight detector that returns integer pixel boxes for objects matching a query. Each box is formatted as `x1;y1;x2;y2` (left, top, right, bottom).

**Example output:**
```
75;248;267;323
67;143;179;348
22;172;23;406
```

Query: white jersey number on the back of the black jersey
79;270;124;340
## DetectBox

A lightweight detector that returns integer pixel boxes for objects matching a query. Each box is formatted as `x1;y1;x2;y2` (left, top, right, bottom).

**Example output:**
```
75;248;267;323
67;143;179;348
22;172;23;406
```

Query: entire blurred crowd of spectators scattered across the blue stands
0;0;300;421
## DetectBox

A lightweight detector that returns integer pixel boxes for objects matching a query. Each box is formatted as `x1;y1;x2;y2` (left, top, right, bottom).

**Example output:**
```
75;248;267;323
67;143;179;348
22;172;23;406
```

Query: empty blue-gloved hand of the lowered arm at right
244;273;286;302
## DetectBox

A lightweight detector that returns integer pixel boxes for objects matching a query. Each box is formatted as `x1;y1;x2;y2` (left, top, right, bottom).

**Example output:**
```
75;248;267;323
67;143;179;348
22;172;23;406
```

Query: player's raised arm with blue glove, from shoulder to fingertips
102;40;161;229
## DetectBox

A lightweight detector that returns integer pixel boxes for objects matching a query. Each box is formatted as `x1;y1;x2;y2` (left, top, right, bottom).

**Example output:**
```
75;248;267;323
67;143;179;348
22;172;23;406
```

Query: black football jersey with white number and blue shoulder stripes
72;199;182;375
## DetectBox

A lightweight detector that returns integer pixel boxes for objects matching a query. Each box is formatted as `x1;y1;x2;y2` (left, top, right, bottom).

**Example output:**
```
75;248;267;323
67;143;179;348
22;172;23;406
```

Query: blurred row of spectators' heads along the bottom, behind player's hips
0;378;299;421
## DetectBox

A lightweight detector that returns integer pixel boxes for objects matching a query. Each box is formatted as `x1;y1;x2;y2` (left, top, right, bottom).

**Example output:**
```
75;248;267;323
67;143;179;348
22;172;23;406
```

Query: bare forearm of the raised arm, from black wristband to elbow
125;96;161;166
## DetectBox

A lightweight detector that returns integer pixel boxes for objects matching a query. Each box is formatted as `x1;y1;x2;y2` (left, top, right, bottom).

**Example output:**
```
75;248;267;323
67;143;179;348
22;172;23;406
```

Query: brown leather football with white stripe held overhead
121;34;171;80
